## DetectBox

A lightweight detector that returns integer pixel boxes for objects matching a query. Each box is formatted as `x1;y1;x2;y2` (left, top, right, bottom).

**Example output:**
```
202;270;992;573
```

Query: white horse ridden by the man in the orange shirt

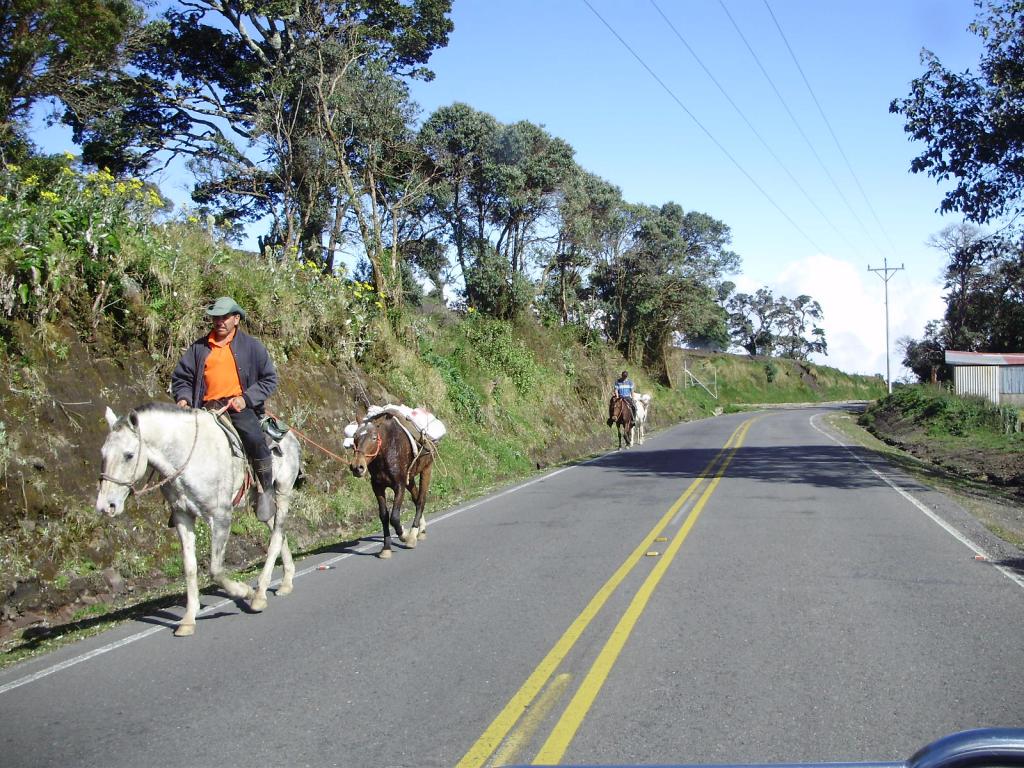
96;402;299;637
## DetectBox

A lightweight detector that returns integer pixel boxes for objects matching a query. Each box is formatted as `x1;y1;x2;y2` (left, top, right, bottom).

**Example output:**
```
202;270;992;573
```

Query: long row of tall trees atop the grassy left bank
0;0;825;378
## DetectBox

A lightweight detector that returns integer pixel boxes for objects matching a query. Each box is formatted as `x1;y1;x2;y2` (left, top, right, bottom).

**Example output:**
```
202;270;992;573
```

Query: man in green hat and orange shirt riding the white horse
171;296;278;522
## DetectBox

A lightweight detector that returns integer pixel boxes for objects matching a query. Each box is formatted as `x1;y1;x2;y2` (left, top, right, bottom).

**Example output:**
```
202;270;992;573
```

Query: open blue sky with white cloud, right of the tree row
405;0;981;379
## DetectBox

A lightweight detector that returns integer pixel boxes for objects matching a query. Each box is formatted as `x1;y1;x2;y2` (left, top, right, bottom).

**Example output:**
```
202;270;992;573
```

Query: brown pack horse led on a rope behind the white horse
348;414;434;559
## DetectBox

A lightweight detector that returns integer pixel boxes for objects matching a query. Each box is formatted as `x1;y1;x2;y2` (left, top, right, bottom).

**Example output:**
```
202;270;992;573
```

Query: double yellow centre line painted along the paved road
458;419;755;768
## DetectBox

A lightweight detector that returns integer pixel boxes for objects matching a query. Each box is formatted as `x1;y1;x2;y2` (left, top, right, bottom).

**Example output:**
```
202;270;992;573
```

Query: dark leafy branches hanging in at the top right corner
889;0;1024;233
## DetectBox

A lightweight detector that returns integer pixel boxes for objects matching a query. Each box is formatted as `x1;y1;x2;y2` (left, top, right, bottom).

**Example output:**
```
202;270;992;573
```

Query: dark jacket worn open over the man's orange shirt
171;329;278;417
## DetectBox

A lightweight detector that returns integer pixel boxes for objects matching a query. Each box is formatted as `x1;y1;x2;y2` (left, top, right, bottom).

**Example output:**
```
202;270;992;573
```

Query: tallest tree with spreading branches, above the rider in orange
67;0;452;268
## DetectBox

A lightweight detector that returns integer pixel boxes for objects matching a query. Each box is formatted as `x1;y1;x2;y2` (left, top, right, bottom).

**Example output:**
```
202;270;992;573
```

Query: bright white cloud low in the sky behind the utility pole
736;255;945;381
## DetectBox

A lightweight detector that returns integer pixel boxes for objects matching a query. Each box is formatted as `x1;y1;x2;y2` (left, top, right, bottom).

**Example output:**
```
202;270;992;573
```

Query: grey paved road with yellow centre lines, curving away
0;409;1024;768
